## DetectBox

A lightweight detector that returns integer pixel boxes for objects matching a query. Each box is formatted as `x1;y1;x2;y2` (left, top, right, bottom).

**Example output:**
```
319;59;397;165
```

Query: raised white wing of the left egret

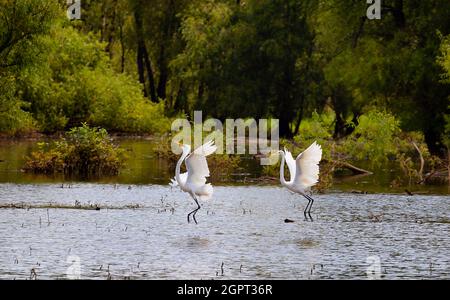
185;141;217;184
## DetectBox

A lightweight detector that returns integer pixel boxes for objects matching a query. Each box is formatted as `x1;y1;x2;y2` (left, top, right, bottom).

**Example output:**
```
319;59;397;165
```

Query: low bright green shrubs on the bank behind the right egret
263;109;443;191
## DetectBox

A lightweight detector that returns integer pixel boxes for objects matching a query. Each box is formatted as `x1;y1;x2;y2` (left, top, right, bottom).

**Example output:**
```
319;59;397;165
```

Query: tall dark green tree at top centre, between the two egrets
173;0;320;137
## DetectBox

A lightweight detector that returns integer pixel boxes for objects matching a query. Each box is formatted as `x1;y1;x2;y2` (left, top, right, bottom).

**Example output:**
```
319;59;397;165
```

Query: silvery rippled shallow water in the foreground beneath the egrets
0;183;450;279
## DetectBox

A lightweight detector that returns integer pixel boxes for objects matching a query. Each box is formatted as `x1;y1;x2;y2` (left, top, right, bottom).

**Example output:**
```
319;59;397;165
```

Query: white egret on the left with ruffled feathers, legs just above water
170;141;217;224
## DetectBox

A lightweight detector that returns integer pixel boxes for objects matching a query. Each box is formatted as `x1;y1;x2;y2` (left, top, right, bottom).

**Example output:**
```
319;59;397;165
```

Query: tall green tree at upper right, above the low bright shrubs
318;0;450;152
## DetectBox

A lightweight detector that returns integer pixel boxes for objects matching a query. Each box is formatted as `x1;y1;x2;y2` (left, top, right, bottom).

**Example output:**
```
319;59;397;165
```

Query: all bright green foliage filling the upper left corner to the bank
0;0;170;134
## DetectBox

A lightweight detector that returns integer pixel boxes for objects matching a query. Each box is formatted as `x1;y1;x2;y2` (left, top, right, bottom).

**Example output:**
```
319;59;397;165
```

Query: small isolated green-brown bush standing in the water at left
24;124;125;177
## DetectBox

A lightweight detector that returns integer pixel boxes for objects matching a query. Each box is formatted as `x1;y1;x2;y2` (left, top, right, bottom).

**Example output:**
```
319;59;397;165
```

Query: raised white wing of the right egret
294;142;322;188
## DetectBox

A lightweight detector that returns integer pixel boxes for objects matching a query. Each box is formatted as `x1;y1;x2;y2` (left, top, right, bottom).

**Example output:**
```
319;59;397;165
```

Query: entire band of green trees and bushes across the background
0;0;450;190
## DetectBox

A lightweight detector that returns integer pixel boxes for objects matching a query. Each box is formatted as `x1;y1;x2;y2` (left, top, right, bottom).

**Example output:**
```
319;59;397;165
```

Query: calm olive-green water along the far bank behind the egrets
0;138;450;195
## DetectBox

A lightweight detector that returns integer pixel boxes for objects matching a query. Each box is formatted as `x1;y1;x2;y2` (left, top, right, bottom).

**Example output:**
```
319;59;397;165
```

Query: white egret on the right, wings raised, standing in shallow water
278;142;322;220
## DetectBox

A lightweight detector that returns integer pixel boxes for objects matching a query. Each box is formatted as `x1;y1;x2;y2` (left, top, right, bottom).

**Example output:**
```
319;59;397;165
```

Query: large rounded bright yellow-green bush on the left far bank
18;21;170;134
